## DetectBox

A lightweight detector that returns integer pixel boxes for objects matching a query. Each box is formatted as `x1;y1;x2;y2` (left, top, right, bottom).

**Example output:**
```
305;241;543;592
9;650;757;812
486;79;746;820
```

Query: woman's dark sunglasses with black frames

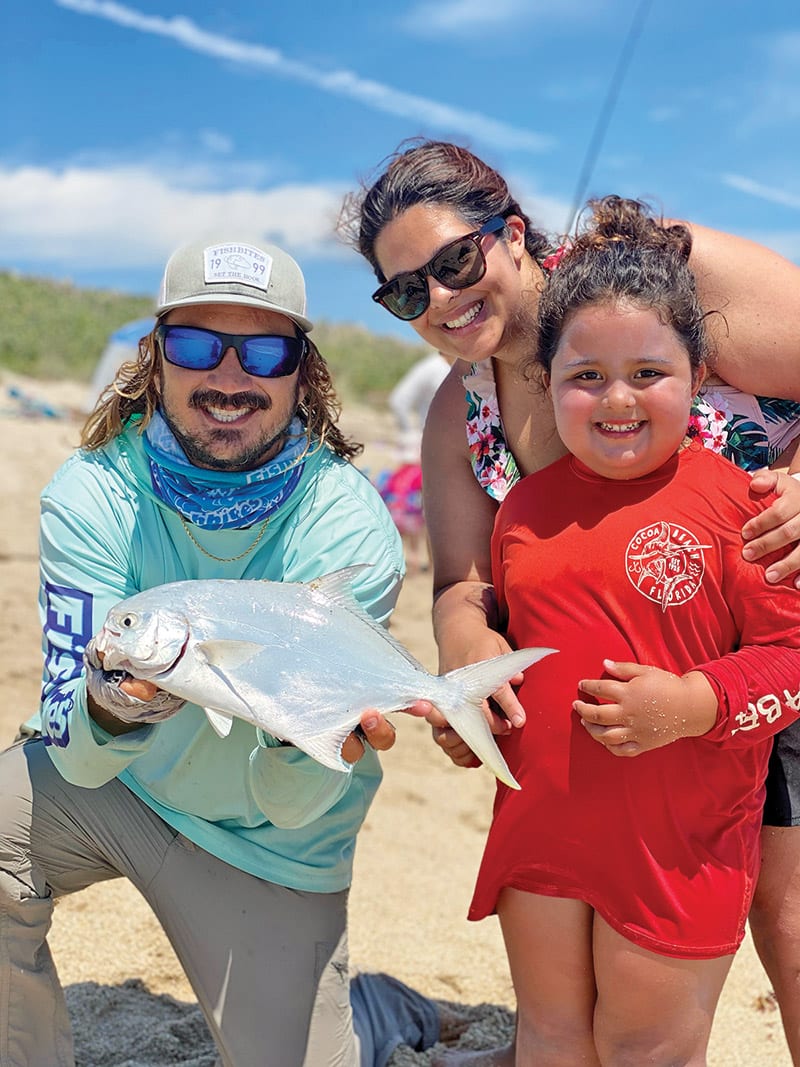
372;216;506;322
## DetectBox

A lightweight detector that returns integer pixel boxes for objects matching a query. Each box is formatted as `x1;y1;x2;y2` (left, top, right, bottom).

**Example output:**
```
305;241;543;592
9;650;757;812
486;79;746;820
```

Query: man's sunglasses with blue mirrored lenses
155;323;307;378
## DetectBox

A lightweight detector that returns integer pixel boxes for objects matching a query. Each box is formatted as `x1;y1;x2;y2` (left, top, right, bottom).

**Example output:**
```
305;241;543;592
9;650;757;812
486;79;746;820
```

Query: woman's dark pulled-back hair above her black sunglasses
338;140;550;282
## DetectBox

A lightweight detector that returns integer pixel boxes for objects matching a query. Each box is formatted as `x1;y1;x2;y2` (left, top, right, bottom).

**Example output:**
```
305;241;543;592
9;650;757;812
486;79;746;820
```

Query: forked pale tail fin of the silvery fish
437;649;558;790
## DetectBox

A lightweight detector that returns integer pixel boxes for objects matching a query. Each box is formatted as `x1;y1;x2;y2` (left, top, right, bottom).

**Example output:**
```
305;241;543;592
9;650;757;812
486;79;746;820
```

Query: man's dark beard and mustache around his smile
160;381;300;471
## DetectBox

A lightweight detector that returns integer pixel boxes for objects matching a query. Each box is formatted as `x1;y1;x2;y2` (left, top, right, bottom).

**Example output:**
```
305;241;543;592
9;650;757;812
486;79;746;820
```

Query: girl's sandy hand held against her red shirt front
573;659;718;755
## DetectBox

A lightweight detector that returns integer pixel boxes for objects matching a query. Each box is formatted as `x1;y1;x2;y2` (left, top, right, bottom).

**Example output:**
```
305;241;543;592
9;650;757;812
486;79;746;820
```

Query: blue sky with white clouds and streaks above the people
0;0;800;339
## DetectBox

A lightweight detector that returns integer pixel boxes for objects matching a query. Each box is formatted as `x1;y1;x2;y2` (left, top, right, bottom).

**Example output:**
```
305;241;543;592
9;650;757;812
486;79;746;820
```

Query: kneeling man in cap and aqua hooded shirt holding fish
0;240;438;1067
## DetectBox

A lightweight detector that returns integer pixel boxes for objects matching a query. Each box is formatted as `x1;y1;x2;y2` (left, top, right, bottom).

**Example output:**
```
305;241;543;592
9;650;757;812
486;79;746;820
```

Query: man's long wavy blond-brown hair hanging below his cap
81;329;364;460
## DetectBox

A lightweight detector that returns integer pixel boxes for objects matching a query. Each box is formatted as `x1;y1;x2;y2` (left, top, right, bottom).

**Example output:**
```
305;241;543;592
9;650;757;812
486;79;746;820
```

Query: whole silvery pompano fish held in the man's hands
96;564;556;789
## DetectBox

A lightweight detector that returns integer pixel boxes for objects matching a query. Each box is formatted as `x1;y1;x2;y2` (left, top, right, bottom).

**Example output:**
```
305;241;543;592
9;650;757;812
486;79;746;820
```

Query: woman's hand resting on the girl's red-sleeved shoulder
741;469;800;589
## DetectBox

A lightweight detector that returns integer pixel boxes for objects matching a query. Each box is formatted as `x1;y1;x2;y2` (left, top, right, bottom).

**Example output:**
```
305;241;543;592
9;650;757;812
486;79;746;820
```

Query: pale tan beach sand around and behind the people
0;376;790;1067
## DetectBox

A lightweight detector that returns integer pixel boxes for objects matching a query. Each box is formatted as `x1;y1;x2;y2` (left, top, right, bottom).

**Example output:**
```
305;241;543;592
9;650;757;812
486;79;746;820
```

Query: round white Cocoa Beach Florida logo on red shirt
625;522;713;611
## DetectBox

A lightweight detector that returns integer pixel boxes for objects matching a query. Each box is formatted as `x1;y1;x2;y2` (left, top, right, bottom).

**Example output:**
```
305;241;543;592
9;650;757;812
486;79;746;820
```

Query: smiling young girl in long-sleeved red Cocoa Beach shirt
470;197;800;1067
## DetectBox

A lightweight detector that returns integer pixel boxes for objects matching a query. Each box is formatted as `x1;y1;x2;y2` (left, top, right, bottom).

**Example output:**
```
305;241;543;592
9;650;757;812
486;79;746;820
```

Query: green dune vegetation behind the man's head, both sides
0;271;426;404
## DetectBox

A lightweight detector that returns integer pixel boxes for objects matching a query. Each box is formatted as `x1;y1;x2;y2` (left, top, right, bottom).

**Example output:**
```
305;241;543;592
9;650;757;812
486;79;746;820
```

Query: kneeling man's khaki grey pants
0;739;358;1067
